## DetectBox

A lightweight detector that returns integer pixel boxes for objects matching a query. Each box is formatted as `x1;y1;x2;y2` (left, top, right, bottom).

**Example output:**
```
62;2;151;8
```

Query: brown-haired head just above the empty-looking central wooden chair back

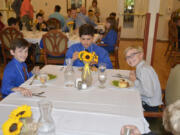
47;18;61;30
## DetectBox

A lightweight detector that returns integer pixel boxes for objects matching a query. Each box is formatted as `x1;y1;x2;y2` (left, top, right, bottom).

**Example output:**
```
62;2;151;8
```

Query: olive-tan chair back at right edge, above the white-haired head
165;64;180;105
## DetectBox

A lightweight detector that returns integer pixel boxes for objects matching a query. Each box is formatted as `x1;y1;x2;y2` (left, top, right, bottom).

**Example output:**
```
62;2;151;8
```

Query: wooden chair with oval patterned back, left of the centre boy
42;30;68;64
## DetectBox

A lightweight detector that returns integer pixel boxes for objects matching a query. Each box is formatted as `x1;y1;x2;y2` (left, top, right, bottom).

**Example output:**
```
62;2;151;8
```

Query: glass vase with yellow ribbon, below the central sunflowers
81;63;93;87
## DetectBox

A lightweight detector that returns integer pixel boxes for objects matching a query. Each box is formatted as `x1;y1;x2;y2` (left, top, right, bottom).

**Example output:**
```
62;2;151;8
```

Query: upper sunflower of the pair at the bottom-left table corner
10;105;32;118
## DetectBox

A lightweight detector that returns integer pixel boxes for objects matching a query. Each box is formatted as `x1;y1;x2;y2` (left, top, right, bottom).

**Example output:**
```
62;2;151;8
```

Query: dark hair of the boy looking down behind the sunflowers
79;24;94;37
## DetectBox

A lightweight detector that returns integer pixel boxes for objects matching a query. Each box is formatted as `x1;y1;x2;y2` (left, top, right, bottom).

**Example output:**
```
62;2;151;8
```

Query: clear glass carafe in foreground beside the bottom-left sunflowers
38;100;55;135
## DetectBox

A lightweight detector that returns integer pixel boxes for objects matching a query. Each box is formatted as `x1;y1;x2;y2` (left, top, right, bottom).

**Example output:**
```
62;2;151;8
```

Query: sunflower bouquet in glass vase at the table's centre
78;51;98;86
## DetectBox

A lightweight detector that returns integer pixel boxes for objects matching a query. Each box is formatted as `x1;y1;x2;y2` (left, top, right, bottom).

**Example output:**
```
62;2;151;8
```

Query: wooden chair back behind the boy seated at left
0;27;23;65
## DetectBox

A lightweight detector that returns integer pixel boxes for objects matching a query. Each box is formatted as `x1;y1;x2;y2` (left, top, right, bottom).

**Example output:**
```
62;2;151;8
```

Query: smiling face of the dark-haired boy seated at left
10;47;28;62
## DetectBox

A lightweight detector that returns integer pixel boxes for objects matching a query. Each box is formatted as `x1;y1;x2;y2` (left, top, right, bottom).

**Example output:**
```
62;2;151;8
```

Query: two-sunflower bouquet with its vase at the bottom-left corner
2;105;37;135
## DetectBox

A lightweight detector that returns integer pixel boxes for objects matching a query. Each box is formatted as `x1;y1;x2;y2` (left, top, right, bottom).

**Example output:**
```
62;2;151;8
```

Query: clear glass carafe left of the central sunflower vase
64;59;75;87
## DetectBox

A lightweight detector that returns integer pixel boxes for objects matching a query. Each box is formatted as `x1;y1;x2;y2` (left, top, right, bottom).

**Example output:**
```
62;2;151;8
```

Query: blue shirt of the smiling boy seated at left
1;58;33;97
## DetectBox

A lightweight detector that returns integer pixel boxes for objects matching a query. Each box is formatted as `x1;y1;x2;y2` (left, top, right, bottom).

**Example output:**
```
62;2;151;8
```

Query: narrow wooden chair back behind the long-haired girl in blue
114;27;121;69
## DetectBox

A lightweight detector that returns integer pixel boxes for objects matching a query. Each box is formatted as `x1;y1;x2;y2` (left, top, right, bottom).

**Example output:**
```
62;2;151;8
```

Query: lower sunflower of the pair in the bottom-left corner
2;118;23;135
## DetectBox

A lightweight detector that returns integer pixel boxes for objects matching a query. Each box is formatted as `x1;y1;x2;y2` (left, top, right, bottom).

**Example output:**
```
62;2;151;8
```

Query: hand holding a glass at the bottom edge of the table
121;125;141;135
